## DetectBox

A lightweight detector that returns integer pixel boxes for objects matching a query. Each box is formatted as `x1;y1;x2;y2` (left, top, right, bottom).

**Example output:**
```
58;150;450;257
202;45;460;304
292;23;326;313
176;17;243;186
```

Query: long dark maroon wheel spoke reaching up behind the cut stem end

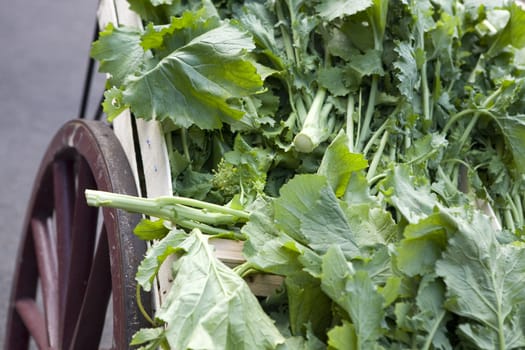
62;158;98;349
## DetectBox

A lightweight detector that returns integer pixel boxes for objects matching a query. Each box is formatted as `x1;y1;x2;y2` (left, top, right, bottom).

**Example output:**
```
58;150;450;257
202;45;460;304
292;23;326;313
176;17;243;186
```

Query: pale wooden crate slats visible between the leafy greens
97;0;282;305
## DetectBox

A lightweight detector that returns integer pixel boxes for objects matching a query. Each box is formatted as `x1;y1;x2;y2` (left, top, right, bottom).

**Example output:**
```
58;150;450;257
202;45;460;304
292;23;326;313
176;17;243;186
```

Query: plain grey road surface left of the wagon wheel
0;0;106;346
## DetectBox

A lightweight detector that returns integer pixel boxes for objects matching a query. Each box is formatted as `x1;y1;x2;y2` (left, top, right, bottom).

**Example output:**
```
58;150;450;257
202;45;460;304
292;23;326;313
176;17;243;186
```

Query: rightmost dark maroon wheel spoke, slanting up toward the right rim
69;227;111;350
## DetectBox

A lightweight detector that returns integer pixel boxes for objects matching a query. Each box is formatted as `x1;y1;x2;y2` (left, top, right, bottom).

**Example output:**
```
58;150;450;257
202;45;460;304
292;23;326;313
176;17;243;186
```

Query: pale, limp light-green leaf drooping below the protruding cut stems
156;230;284;350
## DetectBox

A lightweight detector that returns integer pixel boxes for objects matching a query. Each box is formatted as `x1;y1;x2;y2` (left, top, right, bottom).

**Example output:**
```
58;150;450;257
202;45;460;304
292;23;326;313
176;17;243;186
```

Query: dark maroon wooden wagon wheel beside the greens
5;120;150;350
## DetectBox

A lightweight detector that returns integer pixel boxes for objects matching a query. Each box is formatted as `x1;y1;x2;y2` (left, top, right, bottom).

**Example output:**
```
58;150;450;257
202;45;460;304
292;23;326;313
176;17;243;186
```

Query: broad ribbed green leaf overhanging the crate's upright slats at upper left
123;24;263;129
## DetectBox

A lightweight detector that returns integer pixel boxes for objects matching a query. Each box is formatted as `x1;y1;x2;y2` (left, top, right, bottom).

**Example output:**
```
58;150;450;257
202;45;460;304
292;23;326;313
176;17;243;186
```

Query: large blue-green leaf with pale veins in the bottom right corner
436;214;525;350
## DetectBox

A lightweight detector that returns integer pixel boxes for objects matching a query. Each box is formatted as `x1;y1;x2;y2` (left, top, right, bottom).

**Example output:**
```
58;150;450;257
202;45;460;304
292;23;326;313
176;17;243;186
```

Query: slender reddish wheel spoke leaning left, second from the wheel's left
31;218;60;347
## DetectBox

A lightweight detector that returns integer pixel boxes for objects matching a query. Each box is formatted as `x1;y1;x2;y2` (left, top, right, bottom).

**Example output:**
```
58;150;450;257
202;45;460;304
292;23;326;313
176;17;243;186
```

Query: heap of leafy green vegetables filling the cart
86;0;525;350
